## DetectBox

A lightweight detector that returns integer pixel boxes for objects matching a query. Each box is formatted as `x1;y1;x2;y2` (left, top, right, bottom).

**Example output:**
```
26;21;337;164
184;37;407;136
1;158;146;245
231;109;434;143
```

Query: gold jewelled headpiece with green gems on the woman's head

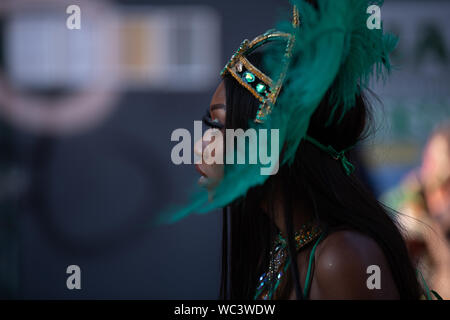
220;6;299;123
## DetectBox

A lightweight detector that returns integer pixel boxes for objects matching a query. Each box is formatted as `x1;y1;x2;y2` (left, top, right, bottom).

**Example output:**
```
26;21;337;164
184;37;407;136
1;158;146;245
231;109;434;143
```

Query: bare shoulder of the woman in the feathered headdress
315;231;398;299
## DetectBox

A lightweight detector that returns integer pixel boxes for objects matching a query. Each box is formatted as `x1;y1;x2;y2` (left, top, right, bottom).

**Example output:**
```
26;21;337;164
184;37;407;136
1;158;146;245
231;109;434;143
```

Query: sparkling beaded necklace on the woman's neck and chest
254;223;321;300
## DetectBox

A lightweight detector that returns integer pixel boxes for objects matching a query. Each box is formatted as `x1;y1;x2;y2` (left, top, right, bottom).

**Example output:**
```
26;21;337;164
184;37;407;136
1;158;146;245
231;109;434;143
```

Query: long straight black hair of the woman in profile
220;48;421;299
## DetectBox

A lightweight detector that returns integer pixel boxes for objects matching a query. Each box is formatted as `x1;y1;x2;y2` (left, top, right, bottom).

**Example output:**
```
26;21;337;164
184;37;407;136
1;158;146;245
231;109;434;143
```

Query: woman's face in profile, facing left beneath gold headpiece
194;81;226;191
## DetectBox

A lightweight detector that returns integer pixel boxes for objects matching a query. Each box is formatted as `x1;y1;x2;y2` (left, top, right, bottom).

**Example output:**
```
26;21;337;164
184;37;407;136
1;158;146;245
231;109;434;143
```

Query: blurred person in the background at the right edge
384;121;450;299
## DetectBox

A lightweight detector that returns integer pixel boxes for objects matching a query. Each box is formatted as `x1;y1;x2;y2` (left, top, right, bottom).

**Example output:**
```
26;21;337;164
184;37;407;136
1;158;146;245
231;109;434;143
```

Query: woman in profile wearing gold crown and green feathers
180;0;428;299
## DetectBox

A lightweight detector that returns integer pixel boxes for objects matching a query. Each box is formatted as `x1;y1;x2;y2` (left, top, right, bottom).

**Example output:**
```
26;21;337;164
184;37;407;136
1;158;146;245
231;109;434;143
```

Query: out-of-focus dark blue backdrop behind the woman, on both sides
0;0;450;299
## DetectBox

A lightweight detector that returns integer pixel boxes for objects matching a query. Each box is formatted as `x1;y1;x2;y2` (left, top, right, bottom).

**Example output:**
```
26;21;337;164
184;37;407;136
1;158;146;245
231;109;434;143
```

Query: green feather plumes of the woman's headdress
158;0;397;223
